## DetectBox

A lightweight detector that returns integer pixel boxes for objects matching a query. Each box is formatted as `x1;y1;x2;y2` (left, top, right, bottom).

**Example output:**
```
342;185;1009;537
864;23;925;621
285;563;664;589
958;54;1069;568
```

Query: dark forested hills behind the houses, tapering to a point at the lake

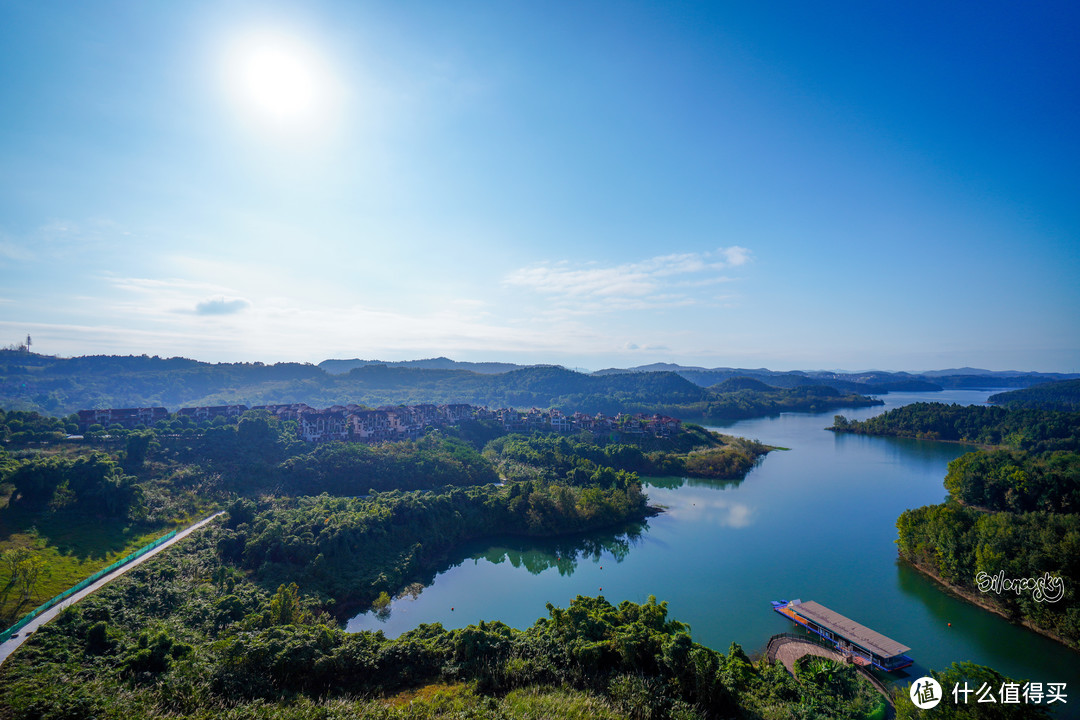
0;352;876;419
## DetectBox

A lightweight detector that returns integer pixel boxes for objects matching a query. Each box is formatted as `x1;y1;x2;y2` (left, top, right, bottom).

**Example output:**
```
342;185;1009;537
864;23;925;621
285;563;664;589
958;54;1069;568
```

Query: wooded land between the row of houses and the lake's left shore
0;410;769;624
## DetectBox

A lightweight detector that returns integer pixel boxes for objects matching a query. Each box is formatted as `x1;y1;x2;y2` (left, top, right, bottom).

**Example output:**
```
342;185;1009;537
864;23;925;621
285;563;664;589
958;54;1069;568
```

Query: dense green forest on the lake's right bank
831;399;1080;649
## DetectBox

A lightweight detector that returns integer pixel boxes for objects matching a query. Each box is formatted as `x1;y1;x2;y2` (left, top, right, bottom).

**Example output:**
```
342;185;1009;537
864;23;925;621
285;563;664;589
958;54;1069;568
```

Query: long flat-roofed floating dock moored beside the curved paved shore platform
772;600;915;673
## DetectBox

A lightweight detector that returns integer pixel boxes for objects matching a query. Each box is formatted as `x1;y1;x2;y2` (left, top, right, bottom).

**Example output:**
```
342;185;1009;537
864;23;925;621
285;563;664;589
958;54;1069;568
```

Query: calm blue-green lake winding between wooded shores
348;391;1080;717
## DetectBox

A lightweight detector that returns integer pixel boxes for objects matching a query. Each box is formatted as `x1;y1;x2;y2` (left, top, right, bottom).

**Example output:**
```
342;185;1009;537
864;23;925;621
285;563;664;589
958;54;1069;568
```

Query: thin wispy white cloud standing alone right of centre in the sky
503;245;752;314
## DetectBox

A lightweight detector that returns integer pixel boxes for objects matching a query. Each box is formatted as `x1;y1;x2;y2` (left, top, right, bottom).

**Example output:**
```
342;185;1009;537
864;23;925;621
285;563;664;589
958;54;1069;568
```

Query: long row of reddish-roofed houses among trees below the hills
79;403;681;443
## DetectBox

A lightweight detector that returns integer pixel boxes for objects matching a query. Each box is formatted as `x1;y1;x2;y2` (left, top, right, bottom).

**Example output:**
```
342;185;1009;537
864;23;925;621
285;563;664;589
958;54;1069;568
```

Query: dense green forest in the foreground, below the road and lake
0;517;902;719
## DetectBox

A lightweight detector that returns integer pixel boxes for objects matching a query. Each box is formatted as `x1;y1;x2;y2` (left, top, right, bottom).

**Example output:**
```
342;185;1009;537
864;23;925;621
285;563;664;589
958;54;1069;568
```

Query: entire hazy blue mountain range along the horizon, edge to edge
0;351;1080;419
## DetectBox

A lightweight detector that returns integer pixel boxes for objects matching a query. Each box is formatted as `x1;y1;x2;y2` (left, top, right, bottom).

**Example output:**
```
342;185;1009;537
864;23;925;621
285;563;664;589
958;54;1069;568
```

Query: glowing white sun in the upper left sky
225;30;338;133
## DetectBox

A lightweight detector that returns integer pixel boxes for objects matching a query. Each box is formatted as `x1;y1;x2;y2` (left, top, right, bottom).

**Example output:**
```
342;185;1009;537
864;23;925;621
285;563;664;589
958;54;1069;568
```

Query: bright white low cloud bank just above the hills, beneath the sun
25;277;615;361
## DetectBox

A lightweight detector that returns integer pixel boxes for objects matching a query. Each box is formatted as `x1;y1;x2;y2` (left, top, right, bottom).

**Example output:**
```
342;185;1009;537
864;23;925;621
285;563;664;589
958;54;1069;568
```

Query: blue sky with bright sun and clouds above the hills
0;0;1080;371
